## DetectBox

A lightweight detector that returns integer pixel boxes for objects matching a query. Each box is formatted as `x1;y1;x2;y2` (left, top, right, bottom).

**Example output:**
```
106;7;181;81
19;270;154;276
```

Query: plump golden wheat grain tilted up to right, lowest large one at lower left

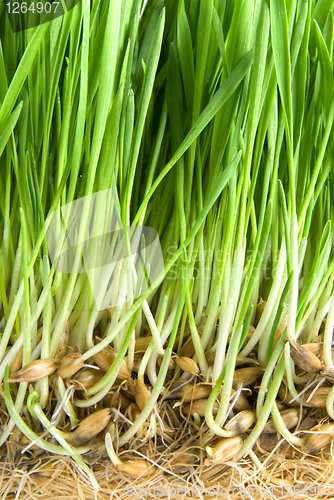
68;408;112;446
